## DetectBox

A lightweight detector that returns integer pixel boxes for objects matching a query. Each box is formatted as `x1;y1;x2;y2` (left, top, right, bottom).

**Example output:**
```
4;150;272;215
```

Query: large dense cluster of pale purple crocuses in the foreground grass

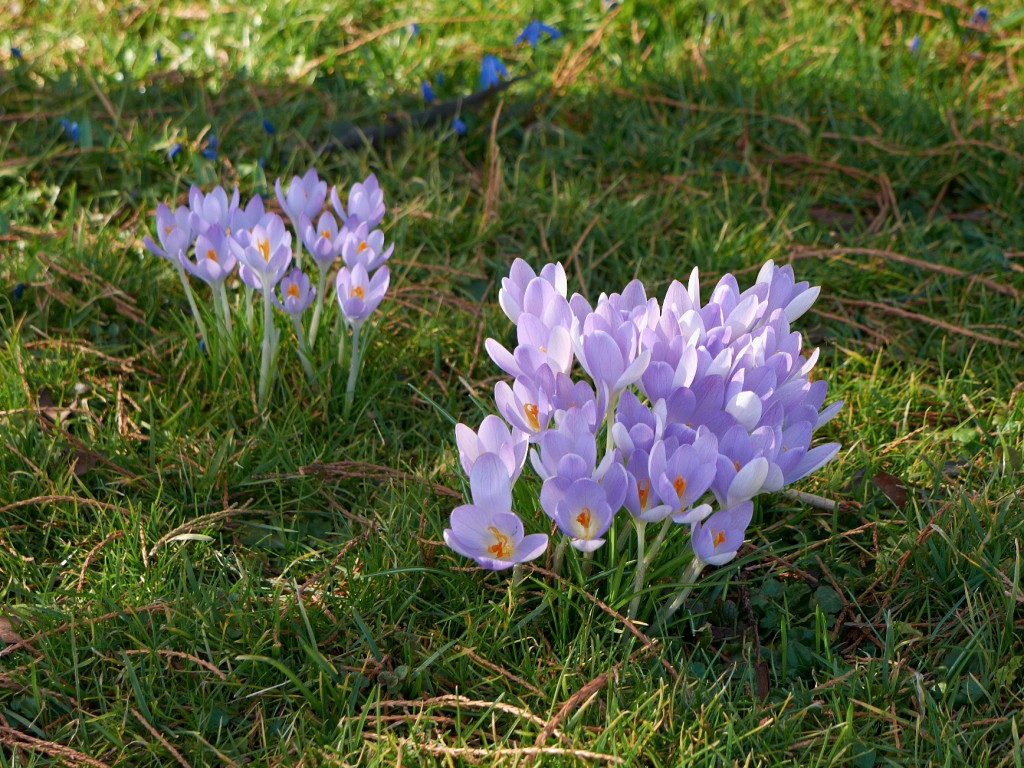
444;259;842;615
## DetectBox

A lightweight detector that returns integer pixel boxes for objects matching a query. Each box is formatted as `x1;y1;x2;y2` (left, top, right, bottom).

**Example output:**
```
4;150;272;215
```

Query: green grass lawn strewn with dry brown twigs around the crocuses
0;0;1024;767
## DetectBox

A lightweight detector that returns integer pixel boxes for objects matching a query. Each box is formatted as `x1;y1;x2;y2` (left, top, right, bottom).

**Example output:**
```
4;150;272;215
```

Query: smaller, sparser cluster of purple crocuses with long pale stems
144;169;394;409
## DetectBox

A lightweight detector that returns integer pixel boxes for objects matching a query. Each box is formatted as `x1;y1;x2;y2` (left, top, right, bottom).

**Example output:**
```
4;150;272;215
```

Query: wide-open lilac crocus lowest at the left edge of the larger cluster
444;454;548;570
